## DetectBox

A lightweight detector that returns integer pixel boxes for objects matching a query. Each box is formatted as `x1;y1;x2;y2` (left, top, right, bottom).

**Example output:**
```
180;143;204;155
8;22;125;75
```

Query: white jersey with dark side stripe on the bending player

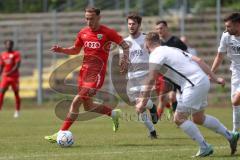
149;46;207;89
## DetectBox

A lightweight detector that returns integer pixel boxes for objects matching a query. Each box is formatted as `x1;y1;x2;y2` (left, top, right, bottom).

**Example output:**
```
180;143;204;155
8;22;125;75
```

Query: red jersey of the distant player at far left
0;51;21;78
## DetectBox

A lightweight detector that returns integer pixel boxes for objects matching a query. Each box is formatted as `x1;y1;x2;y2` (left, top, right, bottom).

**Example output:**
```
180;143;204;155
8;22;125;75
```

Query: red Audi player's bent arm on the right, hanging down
119;41;129;73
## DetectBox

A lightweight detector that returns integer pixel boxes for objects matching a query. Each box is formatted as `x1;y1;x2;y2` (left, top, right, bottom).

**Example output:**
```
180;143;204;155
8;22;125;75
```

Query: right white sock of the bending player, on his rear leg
203;115;232;140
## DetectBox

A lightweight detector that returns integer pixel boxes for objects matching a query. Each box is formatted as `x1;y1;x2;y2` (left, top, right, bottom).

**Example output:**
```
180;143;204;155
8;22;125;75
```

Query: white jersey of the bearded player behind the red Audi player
120;33;149;79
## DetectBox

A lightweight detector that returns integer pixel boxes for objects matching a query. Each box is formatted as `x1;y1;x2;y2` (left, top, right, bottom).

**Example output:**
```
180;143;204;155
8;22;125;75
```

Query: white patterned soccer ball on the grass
57;131;73;147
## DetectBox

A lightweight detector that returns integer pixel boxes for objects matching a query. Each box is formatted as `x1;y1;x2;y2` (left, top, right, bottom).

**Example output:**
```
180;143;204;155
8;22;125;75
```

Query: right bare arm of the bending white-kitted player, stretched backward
192;56;225;86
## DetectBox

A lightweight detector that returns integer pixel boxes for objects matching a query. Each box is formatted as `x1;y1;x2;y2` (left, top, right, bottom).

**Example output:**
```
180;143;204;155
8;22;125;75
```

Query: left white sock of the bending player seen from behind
179;120;208;148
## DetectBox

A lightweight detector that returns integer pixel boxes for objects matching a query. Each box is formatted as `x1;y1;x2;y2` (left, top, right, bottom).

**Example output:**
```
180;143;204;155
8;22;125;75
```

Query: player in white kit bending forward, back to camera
136;32;239;157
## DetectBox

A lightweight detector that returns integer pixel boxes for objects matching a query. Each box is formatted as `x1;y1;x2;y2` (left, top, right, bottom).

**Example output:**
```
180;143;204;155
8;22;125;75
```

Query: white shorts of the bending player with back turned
176;77;210;114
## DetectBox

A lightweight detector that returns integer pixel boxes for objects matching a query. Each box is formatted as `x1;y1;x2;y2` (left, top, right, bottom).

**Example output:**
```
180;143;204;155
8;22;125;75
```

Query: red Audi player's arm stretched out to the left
50;45;81;55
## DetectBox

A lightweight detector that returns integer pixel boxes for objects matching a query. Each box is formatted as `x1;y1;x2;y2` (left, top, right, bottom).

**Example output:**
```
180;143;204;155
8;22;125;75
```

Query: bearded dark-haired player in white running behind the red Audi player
120;13;158;139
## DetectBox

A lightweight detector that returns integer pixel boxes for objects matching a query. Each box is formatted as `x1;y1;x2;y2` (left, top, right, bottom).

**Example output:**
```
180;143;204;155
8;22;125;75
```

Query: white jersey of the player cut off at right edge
218;32;240;74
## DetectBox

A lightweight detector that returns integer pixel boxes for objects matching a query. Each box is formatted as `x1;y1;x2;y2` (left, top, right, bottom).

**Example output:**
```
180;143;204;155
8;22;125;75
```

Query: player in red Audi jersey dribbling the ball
45;7;129;142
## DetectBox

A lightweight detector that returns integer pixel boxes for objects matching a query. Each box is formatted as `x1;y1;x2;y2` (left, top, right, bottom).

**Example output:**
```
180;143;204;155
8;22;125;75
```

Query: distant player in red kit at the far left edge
0;40;21;118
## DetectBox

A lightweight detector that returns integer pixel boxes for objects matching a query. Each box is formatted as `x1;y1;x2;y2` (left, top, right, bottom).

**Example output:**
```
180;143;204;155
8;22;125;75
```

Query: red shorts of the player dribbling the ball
78;70;106;99
